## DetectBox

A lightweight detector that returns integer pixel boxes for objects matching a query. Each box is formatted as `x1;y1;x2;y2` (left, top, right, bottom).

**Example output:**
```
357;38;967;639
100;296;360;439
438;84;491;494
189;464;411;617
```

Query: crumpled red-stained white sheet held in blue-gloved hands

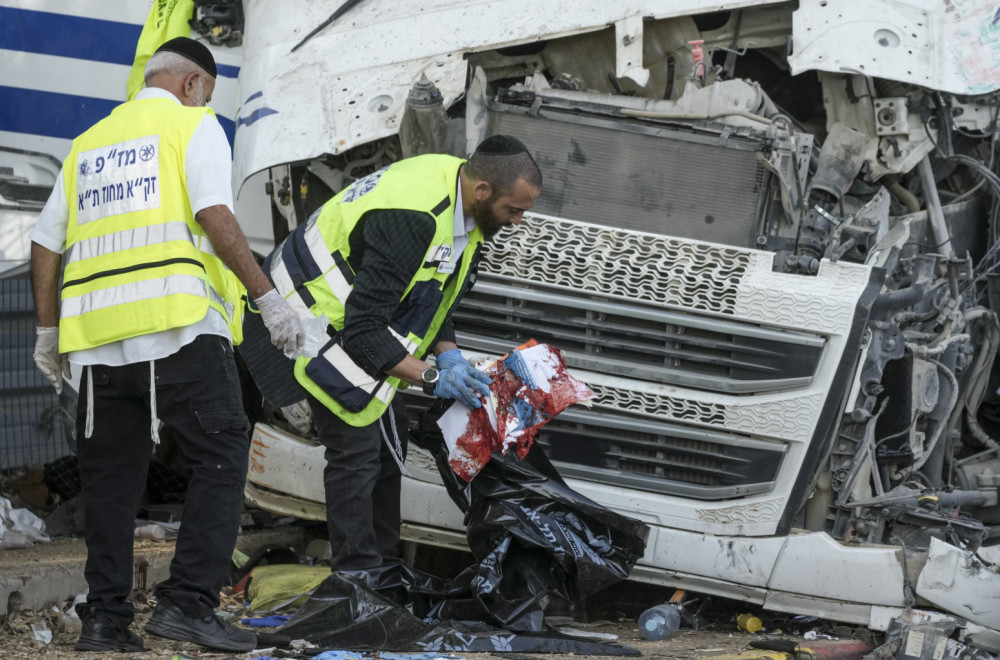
438;340;594;481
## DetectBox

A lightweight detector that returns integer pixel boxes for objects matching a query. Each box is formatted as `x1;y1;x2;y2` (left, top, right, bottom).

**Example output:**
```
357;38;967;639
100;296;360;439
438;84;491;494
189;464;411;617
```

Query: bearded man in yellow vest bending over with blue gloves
264;135;542;571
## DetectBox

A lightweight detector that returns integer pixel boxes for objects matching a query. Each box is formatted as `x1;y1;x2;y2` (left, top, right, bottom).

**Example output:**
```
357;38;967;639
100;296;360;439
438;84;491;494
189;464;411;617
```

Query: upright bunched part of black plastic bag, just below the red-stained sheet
413;416;649;631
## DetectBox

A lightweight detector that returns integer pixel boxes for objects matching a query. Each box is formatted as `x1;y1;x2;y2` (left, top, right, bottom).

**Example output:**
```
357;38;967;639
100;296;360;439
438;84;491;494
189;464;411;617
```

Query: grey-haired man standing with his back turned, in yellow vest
31;37;304;651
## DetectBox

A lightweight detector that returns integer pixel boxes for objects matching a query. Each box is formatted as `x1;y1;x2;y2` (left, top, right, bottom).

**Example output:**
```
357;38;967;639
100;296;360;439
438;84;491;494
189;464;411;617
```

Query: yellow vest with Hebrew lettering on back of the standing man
59;98;245;353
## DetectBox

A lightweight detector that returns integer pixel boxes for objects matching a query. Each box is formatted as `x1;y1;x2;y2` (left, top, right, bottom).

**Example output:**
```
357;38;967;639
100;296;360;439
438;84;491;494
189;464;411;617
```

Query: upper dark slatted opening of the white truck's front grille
454;278;823;394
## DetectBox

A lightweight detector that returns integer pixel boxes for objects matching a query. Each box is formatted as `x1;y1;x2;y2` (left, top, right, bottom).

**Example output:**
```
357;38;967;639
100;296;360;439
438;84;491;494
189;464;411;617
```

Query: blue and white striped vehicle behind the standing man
0;0;273;274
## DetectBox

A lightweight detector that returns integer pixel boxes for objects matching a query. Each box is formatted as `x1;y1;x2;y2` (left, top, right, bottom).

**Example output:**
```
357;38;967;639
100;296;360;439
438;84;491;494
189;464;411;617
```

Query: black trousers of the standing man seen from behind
76;335;250;625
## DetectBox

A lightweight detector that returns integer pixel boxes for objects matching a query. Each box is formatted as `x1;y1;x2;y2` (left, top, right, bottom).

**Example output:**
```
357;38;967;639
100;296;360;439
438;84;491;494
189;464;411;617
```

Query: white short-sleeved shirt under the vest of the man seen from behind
31;87;233;366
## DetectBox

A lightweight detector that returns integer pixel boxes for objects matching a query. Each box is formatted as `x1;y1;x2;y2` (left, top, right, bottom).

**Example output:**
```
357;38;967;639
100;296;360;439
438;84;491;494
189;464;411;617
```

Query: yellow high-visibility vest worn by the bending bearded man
264;154;483;426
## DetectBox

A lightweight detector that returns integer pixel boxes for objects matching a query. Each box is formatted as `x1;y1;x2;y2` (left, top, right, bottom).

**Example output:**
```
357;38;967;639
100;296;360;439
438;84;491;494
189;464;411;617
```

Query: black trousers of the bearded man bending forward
308;396;407;571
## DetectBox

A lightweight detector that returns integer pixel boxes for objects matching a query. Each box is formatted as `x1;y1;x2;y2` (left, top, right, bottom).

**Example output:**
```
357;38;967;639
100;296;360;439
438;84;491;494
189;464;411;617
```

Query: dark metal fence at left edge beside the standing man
0;275;70;470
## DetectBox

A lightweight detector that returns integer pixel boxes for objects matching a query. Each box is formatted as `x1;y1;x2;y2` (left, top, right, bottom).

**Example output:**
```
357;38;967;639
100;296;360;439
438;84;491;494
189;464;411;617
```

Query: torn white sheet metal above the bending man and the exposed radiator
233;0;777;190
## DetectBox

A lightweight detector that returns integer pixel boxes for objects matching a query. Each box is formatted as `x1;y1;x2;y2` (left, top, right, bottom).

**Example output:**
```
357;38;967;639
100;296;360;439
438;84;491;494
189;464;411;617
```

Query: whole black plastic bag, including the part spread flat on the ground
268;404;649;655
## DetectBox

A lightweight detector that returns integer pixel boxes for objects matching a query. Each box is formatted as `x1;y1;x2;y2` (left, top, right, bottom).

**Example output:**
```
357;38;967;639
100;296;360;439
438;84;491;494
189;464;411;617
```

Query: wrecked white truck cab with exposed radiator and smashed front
234;0;1000;651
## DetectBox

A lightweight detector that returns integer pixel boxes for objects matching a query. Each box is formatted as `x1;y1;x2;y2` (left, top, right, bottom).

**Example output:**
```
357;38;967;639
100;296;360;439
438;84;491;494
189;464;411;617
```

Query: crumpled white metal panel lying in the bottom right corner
917;538;1000;629
